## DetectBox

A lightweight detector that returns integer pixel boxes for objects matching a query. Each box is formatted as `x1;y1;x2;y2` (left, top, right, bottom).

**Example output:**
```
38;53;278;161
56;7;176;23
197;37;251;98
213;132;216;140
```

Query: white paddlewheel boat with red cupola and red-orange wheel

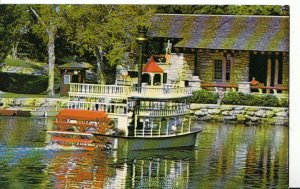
48;57;202;150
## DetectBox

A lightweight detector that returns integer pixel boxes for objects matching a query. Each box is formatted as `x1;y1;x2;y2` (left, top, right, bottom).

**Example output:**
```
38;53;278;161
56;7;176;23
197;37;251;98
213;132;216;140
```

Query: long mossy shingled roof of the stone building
149;14;289;52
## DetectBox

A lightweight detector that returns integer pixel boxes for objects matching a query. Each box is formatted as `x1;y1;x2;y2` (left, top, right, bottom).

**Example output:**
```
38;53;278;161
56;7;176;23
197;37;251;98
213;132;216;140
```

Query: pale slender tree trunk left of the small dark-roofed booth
47;28;56;96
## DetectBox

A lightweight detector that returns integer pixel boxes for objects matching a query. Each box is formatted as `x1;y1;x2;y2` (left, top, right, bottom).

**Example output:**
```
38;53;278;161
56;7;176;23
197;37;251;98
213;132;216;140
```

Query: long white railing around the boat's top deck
69;83;192;99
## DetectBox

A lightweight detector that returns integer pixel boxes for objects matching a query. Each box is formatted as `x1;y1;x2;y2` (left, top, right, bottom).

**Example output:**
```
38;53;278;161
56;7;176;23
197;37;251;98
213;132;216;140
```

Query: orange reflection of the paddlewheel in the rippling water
48;151;111;188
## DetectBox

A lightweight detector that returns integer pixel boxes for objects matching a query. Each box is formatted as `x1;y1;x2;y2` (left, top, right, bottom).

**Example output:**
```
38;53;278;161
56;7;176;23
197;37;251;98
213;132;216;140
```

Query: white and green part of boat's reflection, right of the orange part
110;148;195;188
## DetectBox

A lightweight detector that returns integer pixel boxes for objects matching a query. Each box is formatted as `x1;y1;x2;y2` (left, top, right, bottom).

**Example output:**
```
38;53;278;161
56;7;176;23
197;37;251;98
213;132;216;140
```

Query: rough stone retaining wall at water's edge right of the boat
191;104;289;125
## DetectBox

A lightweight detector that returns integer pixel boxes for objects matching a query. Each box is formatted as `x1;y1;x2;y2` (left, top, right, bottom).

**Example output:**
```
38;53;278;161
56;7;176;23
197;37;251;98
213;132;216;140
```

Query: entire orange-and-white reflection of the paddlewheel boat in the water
48;149;195;188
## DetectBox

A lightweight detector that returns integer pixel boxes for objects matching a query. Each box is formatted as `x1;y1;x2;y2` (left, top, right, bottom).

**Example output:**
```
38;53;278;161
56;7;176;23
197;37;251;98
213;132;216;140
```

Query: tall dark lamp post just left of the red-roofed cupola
136;26;148;87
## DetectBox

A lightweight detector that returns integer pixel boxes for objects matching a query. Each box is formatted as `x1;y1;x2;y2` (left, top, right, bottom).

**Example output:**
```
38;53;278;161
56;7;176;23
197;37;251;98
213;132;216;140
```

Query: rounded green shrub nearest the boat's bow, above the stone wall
191;90;218;104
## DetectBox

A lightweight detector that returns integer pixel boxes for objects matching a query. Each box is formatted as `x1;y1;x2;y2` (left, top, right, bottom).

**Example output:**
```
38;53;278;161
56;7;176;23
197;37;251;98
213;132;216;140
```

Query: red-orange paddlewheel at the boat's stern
52;109;114;147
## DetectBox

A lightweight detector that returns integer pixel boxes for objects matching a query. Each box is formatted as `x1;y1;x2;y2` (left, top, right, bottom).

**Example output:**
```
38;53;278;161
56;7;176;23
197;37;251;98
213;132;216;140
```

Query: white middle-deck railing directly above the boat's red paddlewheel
68;101;127;115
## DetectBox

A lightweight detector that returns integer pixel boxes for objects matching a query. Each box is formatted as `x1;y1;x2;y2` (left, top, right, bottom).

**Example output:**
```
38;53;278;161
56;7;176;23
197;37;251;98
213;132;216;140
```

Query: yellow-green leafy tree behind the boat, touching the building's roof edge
66;5;154;84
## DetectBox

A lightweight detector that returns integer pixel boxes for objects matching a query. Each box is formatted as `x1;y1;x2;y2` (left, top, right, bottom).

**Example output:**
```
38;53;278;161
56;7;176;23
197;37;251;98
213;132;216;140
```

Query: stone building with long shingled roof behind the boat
148;14;289;93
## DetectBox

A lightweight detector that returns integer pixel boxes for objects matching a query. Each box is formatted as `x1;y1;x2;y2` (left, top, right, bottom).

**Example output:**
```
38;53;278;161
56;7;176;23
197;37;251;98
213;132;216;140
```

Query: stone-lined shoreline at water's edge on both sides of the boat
0;97;289;126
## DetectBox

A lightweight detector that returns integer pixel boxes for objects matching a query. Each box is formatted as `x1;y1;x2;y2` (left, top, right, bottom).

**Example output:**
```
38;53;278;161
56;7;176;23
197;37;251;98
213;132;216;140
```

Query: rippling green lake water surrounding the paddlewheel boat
0;117;288;189
